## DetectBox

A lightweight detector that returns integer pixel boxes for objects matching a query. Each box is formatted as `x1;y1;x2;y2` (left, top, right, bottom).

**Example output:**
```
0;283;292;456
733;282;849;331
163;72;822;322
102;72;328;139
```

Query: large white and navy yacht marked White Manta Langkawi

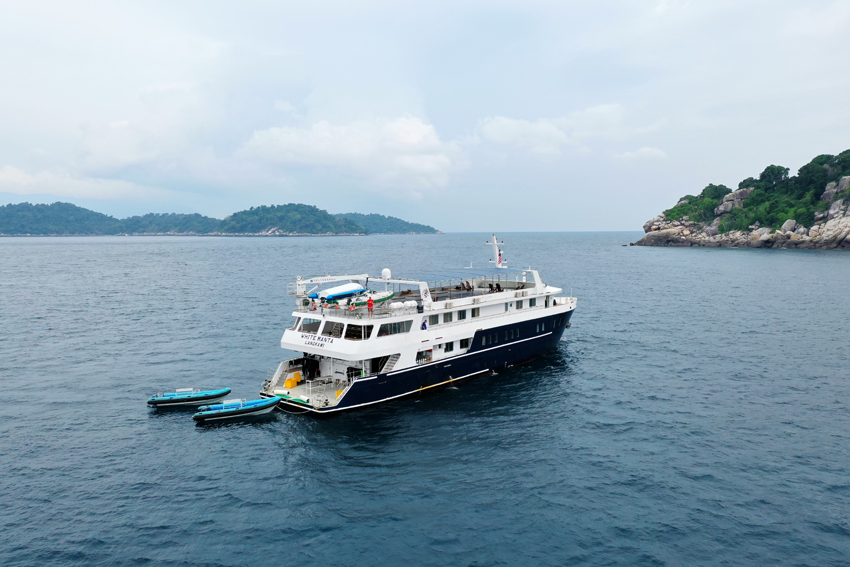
260;235;577;414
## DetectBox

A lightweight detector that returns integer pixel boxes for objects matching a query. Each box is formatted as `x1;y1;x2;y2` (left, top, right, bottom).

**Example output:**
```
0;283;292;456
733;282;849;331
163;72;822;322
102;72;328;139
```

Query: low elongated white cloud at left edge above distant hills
0;165;169;200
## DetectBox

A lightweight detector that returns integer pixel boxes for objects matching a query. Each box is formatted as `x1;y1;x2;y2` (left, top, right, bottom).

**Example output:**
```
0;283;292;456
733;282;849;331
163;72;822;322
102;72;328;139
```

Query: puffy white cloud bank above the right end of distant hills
239;116;460;194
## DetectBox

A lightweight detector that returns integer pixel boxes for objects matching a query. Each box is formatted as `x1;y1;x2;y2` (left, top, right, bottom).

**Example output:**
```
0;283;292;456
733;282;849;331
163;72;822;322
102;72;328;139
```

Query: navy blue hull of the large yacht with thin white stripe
268;311;573;413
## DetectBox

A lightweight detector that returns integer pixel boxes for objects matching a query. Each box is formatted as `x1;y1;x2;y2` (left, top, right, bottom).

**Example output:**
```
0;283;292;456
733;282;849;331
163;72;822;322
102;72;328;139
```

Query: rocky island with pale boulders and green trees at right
633;150;850;249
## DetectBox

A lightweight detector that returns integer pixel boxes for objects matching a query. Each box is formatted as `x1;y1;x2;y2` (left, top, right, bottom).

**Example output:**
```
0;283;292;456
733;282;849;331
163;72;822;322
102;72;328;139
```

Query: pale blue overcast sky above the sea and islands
0;0;850;232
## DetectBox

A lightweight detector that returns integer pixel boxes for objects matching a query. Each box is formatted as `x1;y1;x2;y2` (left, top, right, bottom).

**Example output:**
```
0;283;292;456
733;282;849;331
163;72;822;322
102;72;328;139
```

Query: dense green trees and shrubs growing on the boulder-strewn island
664;150;850;232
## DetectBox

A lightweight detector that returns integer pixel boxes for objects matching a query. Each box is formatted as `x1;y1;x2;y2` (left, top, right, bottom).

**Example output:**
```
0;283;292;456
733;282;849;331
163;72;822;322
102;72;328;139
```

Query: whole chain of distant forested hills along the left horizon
0;203;436;235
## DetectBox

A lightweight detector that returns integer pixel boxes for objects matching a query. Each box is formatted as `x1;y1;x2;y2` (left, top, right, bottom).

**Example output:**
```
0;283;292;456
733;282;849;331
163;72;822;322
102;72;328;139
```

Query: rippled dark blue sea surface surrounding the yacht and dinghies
0;233;850;566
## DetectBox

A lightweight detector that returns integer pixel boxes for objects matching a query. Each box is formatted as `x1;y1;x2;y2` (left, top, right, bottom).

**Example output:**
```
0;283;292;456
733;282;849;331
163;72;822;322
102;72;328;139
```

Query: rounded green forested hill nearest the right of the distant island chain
217;203;366;234
